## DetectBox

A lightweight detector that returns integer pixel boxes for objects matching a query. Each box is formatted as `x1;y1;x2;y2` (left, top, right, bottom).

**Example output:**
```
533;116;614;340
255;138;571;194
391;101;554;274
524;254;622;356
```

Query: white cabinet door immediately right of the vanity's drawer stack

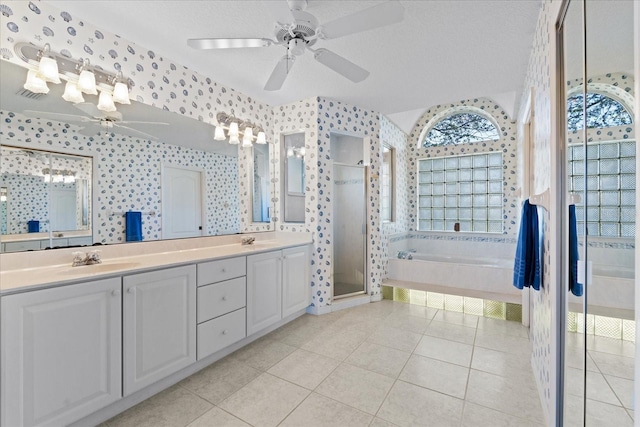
247;251;282;336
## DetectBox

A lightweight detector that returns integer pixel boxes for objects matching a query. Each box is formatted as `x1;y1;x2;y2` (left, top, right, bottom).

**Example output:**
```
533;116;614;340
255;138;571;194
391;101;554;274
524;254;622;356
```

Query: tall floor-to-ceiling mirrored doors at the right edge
558;0;638;426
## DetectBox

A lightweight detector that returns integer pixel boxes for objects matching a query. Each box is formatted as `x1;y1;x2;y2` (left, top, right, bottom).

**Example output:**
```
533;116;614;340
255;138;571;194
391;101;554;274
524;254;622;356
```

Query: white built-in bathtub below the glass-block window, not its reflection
384;252;522;304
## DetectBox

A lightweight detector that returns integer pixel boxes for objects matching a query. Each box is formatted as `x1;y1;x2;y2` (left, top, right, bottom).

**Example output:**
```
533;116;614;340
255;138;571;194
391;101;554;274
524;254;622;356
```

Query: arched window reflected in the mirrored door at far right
567;92;632;132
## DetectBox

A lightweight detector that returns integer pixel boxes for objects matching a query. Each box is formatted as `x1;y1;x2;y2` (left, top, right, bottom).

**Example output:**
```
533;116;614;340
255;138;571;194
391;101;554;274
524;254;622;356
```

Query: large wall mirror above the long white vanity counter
0;61;244;251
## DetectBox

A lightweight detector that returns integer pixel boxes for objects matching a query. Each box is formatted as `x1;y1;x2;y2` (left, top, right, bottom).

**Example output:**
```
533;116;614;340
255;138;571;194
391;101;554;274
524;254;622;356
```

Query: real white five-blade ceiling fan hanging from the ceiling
187;0;404;91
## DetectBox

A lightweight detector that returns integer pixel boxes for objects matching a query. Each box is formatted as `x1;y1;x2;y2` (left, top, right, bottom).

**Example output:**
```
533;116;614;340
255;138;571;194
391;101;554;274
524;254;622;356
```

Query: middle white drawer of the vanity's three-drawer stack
198;276;247;323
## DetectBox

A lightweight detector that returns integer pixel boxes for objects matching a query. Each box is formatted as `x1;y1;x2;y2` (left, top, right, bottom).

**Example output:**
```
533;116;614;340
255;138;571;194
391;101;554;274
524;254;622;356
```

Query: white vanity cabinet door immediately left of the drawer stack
123;265;196;395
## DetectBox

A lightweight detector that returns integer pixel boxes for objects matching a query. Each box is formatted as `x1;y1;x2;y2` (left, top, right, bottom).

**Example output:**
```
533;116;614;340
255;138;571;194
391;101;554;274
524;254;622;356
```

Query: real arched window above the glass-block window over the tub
422;112;500;147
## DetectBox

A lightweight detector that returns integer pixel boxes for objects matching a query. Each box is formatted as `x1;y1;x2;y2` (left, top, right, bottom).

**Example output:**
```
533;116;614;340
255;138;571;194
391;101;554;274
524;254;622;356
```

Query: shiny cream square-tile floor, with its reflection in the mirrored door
105;300;633;427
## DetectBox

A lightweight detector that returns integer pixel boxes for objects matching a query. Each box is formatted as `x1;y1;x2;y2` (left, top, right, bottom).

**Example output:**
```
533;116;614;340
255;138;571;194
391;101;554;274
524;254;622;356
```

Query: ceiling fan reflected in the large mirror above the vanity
24;102;169;141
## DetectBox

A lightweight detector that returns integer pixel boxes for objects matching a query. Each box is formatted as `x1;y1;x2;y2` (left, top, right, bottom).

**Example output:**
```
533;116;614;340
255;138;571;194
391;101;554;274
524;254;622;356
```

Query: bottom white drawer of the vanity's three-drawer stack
198;308;247;359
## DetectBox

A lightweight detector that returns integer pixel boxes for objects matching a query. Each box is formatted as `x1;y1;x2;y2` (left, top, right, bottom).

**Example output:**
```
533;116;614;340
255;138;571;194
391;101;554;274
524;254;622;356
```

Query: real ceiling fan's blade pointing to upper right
318;1;404;39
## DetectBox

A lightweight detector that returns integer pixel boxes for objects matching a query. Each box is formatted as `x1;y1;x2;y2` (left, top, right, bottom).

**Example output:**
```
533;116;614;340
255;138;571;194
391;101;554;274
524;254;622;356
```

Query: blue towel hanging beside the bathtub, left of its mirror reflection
513;200;540;291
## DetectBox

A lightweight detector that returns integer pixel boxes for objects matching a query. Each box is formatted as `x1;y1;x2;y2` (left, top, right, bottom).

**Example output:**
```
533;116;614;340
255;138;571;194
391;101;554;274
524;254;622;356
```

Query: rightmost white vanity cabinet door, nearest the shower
282;246;311;318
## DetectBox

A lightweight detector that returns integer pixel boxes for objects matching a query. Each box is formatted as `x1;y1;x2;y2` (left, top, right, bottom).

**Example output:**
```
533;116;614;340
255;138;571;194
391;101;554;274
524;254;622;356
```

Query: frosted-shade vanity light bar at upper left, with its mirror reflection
15;43;131;112
